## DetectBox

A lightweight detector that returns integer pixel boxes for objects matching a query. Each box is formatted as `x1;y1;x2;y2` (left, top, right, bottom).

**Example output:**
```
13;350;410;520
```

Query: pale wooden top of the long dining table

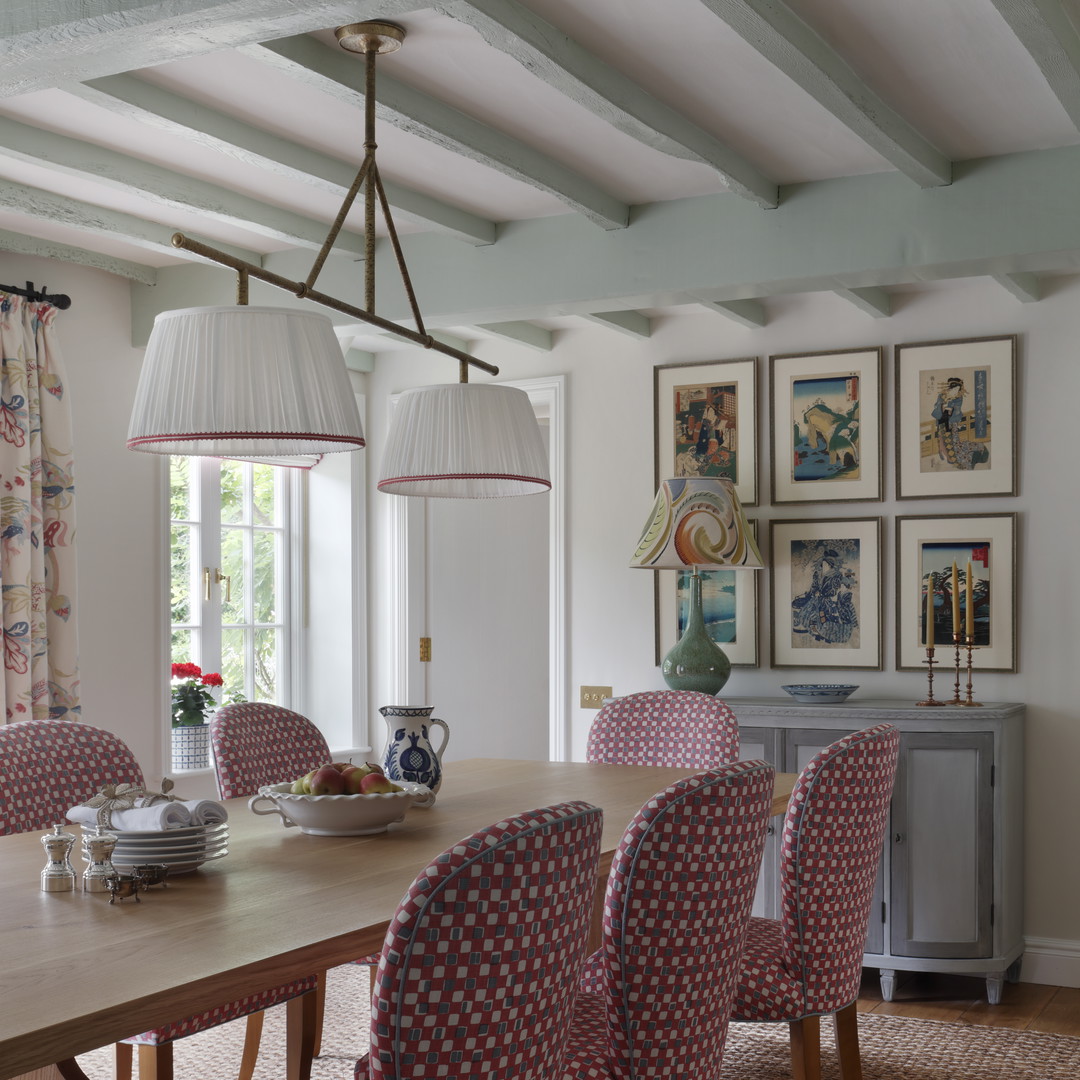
0;758;795;1080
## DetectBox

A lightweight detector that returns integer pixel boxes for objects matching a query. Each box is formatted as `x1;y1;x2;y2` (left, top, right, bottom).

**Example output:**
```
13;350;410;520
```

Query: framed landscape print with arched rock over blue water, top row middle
769;347;885;505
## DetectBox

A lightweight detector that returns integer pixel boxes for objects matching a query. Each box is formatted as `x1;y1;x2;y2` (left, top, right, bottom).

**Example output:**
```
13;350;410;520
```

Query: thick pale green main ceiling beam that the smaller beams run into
139;146;1080;326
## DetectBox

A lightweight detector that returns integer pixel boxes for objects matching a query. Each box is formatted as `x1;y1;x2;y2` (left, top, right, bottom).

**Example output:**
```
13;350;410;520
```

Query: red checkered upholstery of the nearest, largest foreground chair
355;802;603;1080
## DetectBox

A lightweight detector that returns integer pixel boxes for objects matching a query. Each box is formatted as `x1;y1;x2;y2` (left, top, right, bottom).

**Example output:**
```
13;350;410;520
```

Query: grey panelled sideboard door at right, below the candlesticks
889;731;994;958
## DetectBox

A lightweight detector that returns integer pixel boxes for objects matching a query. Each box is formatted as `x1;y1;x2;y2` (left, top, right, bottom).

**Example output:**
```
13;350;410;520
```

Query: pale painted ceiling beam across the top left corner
0;0;408;97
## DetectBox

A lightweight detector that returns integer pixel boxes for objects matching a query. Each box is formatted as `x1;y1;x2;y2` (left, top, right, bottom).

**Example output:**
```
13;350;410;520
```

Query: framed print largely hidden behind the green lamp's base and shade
656;518;761;667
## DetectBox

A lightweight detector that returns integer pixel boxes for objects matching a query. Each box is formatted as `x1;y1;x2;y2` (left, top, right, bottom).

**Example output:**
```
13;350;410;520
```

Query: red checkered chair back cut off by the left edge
0;720;144;835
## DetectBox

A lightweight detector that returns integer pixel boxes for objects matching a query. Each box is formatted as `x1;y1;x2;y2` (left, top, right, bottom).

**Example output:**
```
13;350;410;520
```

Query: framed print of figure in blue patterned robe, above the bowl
769;517;883;671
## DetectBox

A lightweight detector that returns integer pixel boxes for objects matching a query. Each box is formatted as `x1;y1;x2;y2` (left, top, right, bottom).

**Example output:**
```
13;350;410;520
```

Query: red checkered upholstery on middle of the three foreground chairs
561;761;774;1080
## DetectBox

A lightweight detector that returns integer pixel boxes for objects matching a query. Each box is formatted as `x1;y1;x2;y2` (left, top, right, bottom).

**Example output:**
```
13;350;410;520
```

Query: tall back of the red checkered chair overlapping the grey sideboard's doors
780;724;900;1014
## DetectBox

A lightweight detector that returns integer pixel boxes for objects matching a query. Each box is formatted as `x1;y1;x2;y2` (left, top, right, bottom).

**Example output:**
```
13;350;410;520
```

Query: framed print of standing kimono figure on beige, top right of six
895;334;1018;499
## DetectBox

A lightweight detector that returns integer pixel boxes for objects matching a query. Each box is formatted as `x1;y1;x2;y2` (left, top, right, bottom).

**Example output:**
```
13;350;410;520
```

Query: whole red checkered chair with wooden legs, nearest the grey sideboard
731;724;900;1080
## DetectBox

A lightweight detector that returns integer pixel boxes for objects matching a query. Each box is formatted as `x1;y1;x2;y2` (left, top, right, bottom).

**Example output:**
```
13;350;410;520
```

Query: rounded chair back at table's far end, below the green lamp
585;690;739;769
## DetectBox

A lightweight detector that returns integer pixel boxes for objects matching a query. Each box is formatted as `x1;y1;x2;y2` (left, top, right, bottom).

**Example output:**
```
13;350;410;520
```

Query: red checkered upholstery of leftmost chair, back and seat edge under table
0;720;315;1045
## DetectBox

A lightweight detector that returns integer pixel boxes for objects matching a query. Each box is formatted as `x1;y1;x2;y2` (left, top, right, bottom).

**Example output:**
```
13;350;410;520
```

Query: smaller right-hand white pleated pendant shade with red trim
378;382;551;499
